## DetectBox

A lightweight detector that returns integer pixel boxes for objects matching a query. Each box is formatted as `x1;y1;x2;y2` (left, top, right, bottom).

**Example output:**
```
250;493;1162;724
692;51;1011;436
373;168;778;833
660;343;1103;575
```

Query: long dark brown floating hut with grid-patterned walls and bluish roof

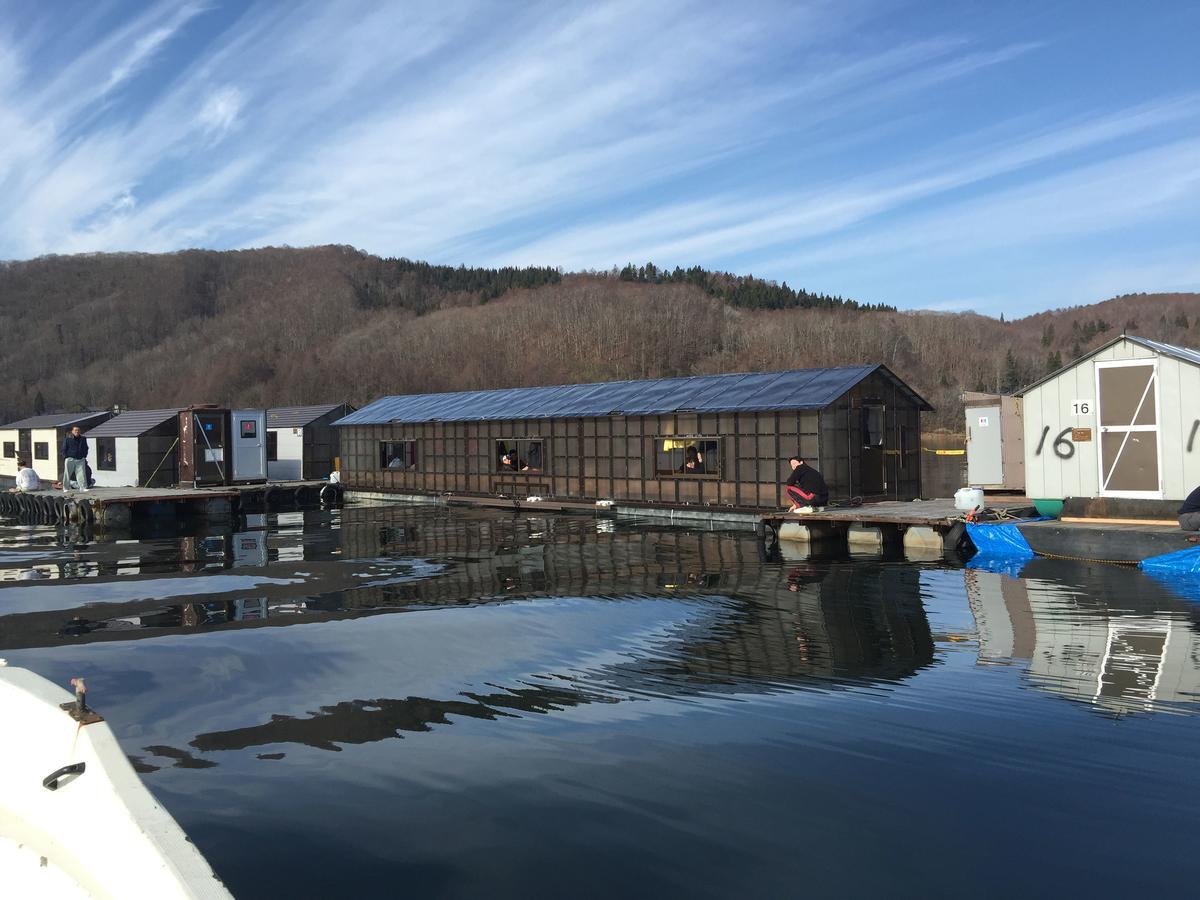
335;365;931;509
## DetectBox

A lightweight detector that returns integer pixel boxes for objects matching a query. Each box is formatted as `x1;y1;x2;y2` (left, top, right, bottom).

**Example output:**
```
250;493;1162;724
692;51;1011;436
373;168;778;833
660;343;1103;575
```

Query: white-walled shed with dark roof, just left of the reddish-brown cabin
86;408;180;487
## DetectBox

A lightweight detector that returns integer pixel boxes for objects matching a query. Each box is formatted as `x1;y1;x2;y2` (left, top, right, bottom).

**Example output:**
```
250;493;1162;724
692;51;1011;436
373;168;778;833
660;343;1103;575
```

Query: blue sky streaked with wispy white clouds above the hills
0;0;1200;317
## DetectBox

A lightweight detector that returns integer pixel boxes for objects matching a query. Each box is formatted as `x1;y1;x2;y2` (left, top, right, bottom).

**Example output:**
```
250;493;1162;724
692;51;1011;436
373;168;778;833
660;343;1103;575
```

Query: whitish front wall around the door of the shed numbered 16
1025;341;1200;500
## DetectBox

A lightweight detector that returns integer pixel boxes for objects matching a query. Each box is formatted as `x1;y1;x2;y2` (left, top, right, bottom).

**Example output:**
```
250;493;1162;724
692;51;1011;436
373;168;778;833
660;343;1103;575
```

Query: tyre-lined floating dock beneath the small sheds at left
0;481;343;528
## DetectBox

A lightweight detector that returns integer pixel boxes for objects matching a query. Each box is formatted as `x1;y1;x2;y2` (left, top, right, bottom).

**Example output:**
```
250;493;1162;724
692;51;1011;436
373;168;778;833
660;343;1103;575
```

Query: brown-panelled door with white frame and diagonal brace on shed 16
1096;360;1163;500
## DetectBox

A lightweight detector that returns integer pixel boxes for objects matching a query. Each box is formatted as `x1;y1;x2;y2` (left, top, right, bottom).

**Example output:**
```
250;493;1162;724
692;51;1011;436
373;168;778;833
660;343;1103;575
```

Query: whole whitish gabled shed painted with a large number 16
1024;335;1200;514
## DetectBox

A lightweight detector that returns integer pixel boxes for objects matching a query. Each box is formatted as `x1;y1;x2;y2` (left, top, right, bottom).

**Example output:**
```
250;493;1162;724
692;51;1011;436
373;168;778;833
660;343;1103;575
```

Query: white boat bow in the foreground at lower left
0;660;232;900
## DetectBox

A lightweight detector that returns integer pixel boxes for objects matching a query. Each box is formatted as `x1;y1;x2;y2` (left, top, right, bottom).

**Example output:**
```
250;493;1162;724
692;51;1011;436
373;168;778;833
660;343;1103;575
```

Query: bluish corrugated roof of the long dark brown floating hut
334;366;932;425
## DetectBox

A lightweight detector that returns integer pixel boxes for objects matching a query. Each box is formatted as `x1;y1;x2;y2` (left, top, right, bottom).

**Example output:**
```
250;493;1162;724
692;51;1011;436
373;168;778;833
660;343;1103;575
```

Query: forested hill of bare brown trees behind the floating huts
0;246;1200;427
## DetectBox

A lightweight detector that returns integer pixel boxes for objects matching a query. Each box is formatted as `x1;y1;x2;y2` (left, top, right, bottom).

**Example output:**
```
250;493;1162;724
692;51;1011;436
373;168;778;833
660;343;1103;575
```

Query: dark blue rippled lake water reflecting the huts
0;506;1200;899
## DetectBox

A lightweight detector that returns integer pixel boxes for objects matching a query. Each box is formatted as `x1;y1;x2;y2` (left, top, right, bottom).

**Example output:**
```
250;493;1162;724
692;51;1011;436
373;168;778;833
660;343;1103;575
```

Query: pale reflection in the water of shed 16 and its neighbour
966;560;1200;713
